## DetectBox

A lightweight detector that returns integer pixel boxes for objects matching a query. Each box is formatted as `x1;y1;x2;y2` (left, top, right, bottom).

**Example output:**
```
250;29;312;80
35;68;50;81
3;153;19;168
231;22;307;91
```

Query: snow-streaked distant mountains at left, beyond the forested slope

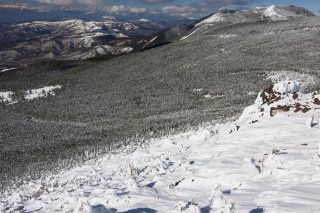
0;17;167;67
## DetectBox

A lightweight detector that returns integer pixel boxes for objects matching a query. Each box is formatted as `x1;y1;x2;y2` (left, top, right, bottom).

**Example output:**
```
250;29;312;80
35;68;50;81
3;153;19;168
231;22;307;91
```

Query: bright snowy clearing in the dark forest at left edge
0;85;61;104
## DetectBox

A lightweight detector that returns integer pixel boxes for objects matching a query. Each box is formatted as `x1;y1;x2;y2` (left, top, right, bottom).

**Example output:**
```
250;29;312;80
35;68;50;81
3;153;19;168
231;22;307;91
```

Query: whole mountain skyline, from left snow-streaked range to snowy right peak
0;6;314;70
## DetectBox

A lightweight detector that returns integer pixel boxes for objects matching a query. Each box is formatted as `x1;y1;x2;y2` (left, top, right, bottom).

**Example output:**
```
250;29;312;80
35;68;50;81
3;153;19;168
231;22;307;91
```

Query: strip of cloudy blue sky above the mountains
0;0;320;21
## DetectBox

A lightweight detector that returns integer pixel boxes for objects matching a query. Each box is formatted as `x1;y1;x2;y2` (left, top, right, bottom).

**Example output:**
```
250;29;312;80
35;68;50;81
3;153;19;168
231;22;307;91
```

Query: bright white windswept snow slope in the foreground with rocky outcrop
0;82;320;213
